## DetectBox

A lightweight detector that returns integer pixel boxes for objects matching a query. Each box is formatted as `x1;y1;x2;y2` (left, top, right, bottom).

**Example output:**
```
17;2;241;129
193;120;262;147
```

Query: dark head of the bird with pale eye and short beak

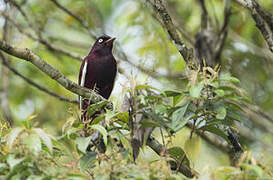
91;35;116;54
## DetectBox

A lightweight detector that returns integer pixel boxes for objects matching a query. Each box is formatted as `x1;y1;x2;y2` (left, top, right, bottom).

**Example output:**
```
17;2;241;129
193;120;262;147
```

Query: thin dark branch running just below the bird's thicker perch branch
0;52;79;104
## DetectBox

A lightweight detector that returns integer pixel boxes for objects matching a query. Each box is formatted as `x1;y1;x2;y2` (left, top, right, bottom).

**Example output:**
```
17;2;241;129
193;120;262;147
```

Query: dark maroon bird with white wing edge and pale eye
79;35;117;121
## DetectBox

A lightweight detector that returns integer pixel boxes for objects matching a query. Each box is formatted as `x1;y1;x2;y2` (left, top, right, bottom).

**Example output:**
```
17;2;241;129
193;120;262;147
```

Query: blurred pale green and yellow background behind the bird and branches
0;0;273;179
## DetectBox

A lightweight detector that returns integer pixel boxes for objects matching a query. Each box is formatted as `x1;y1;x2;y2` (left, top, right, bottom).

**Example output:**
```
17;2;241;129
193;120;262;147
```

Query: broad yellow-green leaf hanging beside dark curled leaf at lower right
184;134;201;162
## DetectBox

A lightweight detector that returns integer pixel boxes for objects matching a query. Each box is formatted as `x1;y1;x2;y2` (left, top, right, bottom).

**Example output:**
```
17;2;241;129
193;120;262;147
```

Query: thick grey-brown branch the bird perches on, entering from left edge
0;41;113;109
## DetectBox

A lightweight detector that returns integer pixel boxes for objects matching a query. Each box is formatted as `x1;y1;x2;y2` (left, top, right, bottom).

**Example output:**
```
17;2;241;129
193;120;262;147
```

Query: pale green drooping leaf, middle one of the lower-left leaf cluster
23;134;42;155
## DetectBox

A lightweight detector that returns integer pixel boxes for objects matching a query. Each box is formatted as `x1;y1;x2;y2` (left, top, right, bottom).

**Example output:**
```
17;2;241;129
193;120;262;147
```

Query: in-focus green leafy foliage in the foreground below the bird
0;69;270;179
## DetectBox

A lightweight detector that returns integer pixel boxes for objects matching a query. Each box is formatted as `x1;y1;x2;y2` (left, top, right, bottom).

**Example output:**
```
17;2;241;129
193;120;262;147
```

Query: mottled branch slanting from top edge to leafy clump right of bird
147;0;193;63
